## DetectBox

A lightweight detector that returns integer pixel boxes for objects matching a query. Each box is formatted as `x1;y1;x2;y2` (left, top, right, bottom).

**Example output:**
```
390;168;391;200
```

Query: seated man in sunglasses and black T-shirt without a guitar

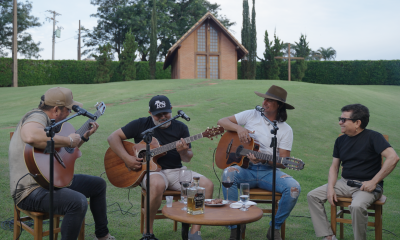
307;104;399;240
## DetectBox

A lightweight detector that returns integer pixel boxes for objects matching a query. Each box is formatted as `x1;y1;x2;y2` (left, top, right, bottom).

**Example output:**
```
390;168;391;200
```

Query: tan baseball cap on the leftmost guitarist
44;87;83;109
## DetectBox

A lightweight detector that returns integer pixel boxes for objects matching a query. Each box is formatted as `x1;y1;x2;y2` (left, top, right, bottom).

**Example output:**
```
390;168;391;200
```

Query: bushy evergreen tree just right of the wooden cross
291;34;311;81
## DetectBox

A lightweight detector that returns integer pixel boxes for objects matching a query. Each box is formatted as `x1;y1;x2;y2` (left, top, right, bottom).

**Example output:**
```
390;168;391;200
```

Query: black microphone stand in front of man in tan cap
44;112;87;240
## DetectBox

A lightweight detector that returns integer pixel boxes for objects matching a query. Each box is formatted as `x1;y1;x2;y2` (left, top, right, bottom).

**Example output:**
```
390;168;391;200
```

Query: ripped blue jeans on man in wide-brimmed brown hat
222;163;301;229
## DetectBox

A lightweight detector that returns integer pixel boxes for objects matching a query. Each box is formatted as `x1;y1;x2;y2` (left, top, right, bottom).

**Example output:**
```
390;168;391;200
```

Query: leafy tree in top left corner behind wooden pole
0;0;43;58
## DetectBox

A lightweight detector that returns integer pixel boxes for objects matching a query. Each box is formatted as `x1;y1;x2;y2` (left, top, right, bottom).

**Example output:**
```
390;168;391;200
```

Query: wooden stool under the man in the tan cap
14;206;85;240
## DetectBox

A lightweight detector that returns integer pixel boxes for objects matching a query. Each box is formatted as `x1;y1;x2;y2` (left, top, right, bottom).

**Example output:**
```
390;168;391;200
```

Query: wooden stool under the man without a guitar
331;195;386;240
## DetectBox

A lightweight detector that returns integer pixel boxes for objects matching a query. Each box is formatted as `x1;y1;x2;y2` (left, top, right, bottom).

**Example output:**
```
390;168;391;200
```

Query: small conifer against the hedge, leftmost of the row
93;43;113;83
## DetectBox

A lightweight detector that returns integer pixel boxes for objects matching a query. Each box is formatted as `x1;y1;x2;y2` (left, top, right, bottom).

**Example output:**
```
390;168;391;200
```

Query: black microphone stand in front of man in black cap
140;114;182;240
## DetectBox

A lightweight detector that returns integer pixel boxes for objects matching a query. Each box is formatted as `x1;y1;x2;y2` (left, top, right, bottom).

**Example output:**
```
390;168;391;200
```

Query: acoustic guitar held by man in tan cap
24;102;106;189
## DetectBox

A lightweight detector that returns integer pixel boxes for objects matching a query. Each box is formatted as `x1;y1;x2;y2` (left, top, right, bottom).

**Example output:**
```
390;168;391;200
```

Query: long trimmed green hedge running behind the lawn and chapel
0;58;400;87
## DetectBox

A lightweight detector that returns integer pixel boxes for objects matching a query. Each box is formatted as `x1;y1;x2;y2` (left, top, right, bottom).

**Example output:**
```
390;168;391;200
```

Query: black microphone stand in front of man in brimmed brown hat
261;112;279;239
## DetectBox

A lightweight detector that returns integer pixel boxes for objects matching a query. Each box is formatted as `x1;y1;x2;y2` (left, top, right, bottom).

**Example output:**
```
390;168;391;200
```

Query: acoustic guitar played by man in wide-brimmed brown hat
215;131;305;170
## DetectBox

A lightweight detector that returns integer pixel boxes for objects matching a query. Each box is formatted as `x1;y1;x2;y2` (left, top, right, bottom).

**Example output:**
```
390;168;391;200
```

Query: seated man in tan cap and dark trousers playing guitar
8;87;115;240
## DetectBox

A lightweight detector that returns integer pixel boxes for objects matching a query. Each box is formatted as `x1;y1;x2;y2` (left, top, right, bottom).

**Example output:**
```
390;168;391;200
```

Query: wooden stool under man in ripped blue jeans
242;188;286;240
